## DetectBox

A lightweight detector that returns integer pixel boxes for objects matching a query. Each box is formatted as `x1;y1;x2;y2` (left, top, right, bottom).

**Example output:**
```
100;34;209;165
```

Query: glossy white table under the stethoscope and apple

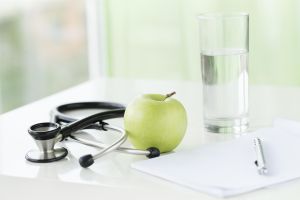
0;79;300;200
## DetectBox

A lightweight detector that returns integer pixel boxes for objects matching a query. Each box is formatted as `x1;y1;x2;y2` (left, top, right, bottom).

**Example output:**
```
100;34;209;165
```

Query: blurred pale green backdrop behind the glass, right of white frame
105;0;300;85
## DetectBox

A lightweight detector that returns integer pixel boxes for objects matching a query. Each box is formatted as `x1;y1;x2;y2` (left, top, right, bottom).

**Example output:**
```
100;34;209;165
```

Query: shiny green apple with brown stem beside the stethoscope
124;92;187;153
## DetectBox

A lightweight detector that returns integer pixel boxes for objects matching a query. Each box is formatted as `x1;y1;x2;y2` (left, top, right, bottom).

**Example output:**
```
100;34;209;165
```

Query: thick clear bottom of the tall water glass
204;117;249;134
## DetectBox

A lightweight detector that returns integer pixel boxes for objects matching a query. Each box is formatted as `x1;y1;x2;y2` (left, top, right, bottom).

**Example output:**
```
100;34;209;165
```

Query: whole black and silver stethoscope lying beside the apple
25;102;160;168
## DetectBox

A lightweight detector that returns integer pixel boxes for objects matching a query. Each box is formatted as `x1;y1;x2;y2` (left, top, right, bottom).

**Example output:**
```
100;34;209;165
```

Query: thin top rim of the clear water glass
197;12;249;19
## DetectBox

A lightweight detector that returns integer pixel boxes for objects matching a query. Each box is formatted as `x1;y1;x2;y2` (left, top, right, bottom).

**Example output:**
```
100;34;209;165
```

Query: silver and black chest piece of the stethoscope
25;122;68;163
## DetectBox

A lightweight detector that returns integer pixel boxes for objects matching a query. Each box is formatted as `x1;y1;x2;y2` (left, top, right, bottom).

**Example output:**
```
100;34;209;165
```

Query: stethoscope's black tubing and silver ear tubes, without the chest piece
51;102;160;168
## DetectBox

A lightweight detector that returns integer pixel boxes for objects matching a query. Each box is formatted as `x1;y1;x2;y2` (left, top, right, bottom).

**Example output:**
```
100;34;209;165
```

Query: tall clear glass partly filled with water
198;13;249;133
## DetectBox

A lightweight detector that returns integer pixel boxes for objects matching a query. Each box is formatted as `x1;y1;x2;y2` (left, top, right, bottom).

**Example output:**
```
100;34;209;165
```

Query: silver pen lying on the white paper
254;137;268;175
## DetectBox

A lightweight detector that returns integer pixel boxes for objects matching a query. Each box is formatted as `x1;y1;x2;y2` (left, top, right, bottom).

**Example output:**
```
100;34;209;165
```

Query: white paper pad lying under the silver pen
132;119;300;197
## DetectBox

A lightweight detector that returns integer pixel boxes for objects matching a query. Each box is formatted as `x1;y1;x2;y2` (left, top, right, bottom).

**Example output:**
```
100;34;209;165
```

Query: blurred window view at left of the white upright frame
0;0;88;112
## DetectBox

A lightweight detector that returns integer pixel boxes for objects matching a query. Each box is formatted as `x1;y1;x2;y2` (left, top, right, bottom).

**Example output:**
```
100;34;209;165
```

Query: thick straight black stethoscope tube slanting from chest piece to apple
60;109;125;141
